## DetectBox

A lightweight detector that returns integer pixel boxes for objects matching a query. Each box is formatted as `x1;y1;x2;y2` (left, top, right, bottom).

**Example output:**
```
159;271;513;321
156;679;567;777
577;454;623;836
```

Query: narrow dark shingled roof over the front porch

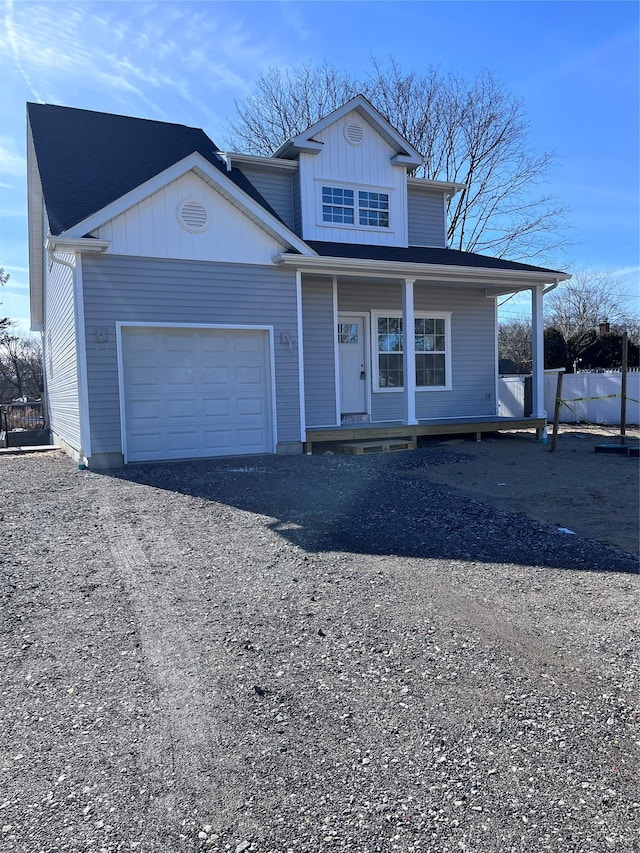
307;240;564;275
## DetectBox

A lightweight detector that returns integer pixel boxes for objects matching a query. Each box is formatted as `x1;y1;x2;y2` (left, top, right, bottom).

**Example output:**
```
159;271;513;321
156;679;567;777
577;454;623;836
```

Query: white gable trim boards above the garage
59;152;316;255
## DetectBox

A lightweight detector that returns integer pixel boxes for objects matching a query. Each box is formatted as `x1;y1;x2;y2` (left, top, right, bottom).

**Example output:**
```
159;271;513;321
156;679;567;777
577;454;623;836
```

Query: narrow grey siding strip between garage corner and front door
302;276;337;428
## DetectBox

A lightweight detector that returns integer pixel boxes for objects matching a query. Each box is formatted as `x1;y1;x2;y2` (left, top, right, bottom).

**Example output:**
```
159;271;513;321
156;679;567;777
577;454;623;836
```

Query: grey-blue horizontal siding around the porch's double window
338;281;497;422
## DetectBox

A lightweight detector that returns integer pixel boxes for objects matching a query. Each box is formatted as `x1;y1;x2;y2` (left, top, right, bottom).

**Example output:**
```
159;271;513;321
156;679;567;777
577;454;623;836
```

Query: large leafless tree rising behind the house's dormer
228;59;567;261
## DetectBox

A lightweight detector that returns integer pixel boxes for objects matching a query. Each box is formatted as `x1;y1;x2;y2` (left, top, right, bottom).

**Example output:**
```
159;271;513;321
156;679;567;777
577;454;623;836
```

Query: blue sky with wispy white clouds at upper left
0;0;640;330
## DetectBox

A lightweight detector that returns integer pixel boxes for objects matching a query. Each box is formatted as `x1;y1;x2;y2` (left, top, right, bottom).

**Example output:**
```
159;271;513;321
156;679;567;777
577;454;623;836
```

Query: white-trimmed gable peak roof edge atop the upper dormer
273;95;424;168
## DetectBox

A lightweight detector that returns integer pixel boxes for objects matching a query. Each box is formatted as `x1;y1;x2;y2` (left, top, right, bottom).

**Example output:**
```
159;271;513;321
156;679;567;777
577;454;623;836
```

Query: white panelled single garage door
122;327;273;462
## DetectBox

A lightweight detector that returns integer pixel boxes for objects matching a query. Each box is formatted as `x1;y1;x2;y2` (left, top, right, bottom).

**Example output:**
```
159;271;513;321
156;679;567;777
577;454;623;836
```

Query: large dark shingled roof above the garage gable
27;104;280;235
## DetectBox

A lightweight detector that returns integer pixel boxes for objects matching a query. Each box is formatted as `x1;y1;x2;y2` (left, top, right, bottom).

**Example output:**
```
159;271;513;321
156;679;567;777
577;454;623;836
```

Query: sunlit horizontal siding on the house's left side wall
43;253;82;452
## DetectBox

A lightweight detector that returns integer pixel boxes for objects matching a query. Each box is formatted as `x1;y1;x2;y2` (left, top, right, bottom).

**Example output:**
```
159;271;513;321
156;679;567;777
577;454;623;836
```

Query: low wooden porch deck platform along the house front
304;417;547;453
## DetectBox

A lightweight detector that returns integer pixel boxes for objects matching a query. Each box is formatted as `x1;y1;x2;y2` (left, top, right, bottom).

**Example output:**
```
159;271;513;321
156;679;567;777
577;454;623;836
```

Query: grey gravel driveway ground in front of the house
0;449;640;853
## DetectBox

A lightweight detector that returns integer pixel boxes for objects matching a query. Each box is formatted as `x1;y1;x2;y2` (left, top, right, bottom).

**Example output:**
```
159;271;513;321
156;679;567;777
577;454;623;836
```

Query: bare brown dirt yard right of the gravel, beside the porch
419;424;640;554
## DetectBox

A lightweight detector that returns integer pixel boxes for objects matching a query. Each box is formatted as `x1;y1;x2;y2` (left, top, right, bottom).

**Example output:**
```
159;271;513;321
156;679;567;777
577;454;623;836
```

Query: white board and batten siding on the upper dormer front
299;111;407;246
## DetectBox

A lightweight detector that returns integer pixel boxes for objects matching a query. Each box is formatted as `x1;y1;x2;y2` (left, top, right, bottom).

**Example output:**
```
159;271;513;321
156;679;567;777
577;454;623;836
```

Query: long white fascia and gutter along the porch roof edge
274;254;570;293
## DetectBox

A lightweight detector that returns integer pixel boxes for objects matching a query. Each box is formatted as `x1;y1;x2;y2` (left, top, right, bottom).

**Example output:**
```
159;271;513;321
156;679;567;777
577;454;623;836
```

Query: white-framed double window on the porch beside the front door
374;314;451;391
